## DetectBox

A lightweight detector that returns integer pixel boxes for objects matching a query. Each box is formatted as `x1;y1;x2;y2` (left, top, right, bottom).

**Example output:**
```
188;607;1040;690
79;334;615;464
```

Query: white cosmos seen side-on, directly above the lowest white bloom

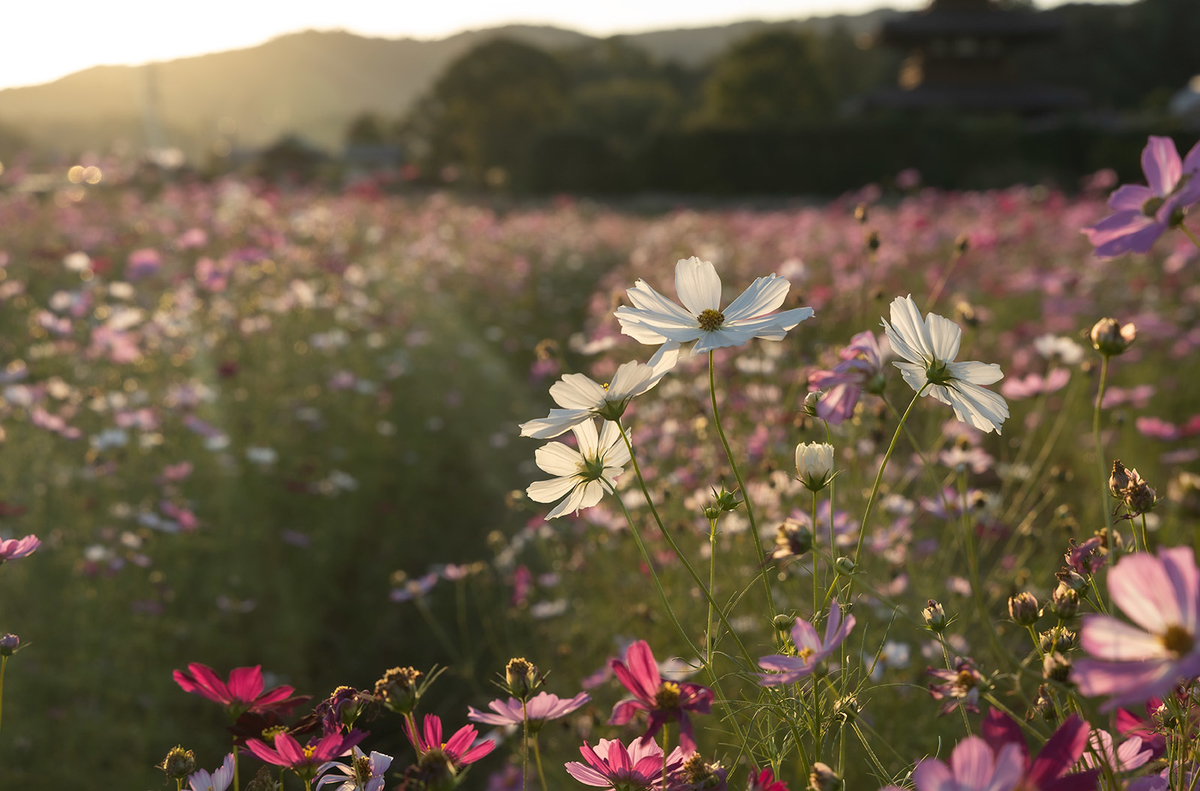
521;341;679;439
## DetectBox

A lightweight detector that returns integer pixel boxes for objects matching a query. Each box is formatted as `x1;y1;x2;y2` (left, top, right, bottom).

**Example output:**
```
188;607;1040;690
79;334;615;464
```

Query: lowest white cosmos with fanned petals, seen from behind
526;420;629;520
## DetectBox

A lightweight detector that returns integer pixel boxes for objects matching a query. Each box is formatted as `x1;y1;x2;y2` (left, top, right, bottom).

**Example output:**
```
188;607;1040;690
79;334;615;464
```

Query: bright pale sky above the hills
0;0;1128;89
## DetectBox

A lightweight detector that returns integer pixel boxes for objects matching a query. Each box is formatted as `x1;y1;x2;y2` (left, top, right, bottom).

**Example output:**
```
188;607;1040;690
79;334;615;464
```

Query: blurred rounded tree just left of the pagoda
704;29;833;127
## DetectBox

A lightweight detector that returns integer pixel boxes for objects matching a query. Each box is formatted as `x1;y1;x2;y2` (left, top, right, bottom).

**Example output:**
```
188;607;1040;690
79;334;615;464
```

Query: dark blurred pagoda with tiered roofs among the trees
868;0;1086;115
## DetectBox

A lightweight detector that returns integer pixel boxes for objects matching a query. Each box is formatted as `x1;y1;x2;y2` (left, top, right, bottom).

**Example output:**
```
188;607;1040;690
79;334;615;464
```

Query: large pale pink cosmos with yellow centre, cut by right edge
1070;546;1200;709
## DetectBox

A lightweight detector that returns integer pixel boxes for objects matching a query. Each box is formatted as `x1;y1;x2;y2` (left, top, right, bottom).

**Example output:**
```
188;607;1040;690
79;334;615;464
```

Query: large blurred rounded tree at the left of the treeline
404;38;568;185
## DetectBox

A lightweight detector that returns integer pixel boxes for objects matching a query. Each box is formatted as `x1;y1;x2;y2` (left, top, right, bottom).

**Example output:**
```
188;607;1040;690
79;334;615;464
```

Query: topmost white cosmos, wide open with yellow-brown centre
617;256;812;354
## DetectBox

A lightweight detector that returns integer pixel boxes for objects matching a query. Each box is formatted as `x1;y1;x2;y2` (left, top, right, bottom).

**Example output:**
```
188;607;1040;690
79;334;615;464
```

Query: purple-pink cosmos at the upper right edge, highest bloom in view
1084;136;1200;258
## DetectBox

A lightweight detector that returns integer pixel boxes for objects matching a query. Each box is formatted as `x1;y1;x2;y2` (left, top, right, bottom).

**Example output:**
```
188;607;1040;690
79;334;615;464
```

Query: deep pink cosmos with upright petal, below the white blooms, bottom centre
608;640;713;753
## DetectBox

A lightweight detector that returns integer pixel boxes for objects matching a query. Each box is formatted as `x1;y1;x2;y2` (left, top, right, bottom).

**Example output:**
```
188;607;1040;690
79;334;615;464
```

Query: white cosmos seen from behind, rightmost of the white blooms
883;296;1008;435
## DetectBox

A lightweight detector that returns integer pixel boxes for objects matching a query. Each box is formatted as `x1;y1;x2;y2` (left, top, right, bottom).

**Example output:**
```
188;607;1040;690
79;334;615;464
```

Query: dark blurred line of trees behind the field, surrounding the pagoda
348;0;1200;193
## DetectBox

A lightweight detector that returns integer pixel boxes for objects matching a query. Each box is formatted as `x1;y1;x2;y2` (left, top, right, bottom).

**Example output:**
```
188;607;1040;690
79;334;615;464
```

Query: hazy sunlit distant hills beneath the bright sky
0;11;896;156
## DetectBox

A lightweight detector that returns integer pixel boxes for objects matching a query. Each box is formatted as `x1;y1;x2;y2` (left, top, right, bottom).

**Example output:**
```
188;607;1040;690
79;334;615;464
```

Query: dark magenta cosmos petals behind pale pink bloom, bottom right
982;708;1099;791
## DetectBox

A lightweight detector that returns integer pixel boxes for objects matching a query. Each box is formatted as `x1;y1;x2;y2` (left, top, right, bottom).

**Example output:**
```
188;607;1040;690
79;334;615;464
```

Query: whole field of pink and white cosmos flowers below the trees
7;140;1200;791
